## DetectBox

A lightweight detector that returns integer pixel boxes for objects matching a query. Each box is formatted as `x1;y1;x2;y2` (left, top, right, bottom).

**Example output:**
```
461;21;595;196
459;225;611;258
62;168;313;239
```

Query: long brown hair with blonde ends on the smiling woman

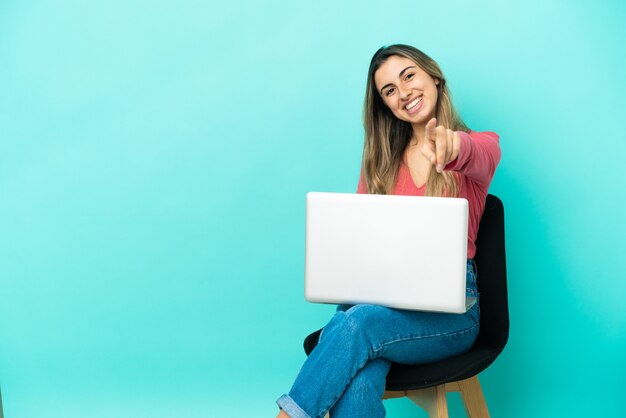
362;44;469;197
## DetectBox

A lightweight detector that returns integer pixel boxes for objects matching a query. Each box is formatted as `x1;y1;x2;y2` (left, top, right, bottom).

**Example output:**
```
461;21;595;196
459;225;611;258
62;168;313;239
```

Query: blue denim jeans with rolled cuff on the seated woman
276;260;480;418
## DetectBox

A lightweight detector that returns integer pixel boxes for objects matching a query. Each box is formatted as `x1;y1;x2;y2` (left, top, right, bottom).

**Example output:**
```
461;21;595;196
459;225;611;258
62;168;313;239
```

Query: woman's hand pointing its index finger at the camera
422;118;461;173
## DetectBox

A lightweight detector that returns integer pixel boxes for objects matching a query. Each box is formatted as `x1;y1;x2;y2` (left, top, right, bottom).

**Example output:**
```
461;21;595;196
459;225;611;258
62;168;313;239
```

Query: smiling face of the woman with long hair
374;55;439;125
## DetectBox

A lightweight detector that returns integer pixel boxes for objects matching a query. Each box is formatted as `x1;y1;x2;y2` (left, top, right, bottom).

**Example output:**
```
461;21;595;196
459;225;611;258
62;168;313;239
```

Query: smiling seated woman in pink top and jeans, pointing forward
277;45;500;418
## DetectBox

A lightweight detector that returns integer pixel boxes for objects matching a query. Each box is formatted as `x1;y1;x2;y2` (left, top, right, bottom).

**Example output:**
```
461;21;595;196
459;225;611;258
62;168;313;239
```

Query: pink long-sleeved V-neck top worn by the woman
357;131;501;258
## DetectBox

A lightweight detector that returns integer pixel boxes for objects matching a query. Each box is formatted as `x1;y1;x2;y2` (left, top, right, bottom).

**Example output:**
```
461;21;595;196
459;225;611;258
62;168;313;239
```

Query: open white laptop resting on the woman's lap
304;192;476;313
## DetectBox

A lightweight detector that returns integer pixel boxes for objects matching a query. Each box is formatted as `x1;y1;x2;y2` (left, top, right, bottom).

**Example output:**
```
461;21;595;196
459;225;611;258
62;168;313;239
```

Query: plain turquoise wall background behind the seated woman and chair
0;0;626;418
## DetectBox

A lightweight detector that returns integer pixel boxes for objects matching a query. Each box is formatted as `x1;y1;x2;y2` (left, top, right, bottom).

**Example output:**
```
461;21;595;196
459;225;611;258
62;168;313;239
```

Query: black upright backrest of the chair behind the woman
474;195;509;352
